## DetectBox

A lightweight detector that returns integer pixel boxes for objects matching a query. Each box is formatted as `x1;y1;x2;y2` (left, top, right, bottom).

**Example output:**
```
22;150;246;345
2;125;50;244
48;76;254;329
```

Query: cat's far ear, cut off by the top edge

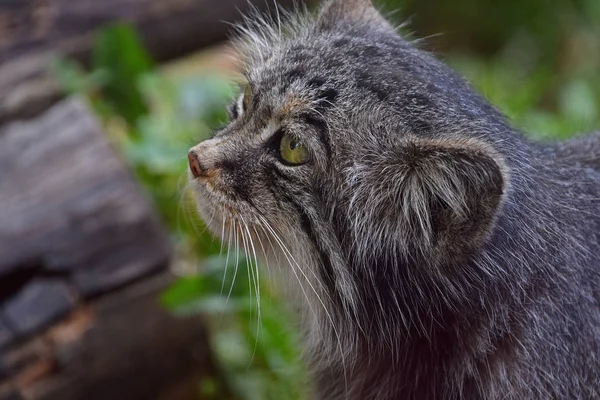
319;0;394;32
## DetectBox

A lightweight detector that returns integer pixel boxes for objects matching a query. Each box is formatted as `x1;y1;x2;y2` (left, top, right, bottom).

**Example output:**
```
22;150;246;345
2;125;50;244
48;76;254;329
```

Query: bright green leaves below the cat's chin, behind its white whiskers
161;254;306;400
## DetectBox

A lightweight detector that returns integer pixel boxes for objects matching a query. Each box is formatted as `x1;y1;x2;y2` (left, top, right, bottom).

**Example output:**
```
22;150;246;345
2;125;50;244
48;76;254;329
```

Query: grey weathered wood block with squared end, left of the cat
0;98;170;342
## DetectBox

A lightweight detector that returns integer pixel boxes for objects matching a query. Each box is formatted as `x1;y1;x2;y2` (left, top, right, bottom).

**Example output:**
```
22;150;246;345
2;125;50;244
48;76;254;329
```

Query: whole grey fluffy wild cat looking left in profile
189;0;600;400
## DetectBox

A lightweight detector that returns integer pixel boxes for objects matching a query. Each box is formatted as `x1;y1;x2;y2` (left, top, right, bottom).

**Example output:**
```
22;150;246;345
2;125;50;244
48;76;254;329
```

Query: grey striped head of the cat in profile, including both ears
189;0;511;312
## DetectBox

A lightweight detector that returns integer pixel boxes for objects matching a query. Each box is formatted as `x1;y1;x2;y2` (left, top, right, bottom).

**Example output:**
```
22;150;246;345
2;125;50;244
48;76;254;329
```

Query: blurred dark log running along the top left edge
0;0;310;123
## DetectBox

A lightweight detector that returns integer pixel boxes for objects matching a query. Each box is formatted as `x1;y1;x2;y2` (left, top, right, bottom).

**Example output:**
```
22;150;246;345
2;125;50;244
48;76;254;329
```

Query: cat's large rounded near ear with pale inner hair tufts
352;139;508;264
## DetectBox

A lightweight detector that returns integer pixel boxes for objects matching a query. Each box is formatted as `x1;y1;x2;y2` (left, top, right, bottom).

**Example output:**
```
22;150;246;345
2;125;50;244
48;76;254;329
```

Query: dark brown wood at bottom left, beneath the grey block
0;275;214;400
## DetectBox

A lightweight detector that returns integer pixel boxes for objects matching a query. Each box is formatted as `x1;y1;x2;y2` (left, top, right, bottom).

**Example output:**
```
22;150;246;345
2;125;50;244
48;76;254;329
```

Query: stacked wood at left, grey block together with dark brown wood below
0;98;214;400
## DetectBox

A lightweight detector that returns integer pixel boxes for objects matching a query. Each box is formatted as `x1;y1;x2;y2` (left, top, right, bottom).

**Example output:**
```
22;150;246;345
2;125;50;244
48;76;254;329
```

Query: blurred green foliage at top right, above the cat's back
382;0;600;139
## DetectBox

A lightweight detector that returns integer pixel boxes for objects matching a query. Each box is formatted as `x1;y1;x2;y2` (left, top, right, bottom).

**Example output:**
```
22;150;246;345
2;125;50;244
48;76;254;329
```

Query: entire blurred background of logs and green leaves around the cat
0;0;600;400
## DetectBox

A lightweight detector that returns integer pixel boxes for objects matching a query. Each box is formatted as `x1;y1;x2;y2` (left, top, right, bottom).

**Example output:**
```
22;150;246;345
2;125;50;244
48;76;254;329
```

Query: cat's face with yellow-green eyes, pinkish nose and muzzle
190;62;336;245
